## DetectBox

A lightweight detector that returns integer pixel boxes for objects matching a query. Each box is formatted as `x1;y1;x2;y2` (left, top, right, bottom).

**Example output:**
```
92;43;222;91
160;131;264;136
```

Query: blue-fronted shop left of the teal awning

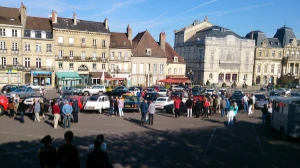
30;71;52;86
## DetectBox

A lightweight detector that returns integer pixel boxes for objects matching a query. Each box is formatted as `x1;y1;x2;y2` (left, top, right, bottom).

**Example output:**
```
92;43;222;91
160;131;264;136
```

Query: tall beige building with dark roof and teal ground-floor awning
51;11;110;86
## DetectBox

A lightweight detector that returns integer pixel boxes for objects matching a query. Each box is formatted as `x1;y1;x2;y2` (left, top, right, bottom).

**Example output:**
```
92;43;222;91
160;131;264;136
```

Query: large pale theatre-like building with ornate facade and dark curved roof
174;18;255;87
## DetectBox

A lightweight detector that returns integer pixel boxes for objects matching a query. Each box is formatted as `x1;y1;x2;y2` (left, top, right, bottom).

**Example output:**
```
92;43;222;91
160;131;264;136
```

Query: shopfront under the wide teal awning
56;72;81;86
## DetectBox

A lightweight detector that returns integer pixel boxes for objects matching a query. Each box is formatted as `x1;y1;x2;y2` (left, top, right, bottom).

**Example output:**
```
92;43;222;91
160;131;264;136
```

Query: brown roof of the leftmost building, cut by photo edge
0;6;21;26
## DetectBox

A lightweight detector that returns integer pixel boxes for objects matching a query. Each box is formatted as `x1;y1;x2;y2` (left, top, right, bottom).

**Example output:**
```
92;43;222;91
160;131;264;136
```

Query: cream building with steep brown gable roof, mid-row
131;30;167;86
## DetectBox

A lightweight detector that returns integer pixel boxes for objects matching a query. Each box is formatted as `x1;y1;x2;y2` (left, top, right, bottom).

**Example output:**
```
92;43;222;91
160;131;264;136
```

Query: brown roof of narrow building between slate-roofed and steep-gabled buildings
110;32;131;49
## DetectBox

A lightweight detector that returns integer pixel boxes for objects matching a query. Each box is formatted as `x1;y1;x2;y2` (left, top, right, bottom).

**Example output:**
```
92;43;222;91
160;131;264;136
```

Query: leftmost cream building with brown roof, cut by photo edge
0;3;27;85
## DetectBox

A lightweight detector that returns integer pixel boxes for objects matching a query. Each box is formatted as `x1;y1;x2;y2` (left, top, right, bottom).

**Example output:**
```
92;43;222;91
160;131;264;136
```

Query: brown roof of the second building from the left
25;16;52;31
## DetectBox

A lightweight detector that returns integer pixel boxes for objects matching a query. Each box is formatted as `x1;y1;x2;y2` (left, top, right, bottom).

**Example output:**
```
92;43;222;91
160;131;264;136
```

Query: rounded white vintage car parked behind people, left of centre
84;95;110;113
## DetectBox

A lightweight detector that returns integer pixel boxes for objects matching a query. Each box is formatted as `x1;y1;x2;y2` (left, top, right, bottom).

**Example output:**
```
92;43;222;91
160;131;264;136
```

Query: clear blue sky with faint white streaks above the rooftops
1;0;300;46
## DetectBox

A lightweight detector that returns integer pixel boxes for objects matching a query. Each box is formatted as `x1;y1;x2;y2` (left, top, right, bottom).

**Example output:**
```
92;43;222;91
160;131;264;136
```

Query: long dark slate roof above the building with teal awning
53;17;109;33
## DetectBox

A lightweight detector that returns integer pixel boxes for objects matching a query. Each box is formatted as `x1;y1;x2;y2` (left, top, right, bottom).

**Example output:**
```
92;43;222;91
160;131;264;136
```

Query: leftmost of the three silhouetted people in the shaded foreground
38;135;56;168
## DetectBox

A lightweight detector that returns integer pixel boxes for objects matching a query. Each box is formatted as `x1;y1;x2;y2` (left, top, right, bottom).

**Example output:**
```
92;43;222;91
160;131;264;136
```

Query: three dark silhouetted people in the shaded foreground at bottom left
38;131;113;168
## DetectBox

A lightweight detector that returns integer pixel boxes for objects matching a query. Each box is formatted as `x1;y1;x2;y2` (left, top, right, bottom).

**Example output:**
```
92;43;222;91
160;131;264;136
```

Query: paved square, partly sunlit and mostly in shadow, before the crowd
0;91;300;168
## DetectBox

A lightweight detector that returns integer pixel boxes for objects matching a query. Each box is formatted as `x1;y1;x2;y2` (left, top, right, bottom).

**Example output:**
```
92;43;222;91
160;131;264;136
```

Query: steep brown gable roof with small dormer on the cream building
132;30;167;58
